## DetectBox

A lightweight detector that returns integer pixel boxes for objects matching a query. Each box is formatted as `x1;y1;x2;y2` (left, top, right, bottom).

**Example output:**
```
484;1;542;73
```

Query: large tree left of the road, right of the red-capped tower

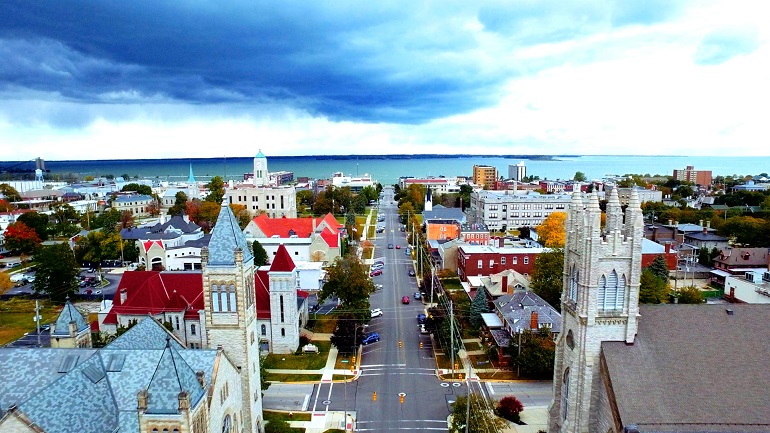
318;254;374;323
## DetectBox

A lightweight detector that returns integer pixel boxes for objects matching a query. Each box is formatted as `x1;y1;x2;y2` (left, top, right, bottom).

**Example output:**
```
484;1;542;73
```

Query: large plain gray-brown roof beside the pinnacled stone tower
602;304;770;432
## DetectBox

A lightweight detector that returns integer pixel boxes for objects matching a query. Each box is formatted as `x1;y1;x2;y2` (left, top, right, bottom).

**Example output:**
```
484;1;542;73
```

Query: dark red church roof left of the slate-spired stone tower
104;271;203;325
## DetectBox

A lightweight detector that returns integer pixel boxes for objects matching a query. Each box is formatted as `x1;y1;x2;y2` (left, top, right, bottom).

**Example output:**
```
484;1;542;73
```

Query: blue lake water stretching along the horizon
10;155;770;184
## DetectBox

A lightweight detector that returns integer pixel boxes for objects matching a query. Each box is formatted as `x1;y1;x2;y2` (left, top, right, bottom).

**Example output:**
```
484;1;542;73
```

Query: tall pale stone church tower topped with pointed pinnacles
548;188;644;433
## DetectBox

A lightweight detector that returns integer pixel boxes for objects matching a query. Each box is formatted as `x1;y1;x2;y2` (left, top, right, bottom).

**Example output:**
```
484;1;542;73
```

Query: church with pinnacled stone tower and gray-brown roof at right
548;188;770;433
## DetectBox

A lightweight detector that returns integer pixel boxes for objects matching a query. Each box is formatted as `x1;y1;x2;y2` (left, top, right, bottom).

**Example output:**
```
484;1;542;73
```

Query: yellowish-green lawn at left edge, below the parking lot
0;297;62;346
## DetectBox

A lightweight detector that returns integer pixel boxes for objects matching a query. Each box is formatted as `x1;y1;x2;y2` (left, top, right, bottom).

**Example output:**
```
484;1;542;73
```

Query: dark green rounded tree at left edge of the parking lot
32;244;80;302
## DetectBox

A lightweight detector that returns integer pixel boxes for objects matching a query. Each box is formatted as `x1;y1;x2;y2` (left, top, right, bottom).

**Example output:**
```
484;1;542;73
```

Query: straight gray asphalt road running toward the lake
348;188;456;431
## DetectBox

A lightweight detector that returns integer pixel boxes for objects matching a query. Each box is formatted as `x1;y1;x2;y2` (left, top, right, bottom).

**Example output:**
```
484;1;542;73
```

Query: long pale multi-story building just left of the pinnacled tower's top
469;190;570;230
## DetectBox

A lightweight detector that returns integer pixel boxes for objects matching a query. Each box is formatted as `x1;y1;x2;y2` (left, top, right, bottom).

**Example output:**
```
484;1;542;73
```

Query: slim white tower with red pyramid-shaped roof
268;244;300;353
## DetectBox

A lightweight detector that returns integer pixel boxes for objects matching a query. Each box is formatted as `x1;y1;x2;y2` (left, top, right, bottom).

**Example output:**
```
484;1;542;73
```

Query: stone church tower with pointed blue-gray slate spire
201;203;264;433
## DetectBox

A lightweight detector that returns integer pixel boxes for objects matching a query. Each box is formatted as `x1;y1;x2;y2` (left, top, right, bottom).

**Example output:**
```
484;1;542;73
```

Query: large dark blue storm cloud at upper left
0;1;509;123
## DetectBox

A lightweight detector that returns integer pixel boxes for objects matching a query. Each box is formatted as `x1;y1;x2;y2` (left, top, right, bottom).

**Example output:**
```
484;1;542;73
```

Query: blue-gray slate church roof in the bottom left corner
0;318;218;433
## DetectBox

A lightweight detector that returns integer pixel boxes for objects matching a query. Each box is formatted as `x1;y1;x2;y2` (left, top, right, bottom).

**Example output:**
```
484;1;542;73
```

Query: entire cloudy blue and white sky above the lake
0;0;770;160
